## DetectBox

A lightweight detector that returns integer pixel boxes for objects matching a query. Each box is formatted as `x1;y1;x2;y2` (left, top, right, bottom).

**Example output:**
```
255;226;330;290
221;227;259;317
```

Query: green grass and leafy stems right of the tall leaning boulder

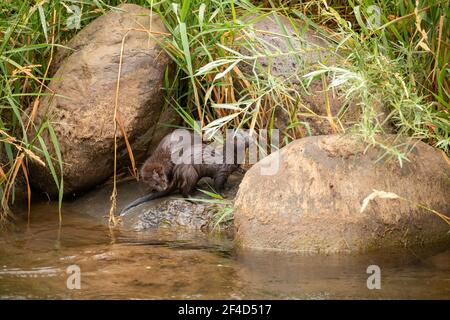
150;1;450;160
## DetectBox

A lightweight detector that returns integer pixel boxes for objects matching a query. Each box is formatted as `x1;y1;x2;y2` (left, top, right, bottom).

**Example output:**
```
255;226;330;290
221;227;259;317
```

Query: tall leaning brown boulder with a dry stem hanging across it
31;4;175;195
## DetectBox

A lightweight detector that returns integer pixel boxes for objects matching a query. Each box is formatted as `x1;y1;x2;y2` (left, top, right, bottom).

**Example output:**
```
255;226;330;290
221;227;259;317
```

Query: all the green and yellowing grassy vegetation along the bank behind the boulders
0;0;450;218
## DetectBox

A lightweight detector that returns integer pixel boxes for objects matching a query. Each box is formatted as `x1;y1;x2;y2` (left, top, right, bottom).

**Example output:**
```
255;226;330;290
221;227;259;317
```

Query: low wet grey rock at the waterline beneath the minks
64;172;243;233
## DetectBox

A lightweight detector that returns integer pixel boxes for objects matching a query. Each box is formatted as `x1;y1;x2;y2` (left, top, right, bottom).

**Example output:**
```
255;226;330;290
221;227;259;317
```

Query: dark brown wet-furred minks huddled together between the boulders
120;132;248;216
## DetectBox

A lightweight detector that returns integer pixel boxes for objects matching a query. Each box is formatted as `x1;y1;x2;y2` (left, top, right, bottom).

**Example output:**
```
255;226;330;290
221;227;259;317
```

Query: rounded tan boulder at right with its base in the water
234;135;450;253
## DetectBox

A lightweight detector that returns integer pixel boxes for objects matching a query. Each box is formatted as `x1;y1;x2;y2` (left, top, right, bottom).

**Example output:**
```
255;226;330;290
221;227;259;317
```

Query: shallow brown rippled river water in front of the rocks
0;204;450;299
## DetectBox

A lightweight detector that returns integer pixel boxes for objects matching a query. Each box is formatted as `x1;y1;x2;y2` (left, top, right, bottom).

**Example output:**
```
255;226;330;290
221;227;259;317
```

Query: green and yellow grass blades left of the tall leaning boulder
0;0;109;222
